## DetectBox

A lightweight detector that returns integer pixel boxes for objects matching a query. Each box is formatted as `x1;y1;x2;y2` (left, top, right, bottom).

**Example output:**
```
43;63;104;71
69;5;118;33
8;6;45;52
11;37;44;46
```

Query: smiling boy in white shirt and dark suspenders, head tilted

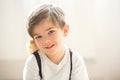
23;4;89;80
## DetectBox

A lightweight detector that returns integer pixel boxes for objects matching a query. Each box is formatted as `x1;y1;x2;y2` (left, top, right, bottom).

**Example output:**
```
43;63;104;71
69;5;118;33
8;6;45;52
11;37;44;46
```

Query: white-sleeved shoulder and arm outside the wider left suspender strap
23;54;40;80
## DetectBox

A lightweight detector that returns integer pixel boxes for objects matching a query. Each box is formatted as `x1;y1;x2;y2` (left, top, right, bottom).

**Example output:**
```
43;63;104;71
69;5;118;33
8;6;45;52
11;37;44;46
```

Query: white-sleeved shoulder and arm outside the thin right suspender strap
72;50;89;80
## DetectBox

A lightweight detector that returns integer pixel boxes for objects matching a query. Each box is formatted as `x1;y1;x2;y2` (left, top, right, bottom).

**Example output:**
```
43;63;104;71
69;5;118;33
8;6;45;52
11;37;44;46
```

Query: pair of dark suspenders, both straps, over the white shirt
33;49;72;80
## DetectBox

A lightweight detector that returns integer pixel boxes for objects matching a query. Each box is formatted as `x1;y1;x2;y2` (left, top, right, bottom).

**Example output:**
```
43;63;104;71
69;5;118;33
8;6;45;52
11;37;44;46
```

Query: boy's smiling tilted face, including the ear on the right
33;20;68;55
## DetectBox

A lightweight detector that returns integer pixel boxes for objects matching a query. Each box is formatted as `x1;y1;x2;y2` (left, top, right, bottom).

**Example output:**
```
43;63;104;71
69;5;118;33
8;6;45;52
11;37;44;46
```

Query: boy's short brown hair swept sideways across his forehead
27;4;65;38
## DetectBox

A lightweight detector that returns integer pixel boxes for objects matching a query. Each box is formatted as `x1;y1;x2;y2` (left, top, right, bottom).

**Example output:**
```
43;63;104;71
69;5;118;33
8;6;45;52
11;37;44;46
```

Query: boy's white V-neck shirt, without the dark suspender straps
23;48;89;80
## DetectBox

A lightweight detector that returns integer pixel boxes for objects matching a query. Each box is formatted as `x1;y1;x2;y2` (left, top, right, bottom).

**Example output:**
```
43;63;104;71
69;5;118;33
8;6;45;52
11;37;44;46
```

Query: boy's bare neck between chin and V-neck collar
47;48;65;64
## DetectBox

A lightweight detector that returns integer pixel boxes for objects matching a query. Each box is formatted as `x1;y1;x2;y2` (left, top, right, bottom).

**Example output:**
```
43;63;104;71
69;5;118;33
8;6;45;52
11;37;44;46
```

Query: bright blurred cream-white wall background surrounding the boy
0;0;120;80
